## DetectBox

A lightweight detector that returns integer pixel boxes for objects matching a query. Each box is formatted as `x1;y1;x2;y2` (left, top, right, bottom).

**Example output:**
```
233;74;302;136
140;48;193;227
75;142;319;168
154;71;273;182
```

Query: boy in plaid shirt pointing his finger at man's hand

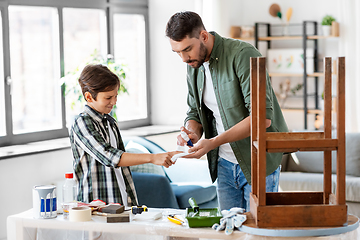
70;65;178;206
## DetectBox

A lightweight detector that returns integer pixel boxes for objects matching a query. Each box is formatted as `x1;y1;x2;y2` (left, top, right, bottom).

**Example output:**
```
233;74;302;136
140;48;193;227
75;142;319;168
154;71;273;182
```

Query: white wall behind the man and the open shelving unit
149;0;340;129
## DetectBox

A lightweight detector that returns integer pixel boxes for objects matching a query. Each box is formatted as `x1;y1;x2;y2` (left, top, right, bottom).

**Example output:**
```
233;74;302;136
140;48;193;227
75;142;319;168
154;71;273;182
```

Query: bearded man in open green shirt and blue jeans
166;12;288;211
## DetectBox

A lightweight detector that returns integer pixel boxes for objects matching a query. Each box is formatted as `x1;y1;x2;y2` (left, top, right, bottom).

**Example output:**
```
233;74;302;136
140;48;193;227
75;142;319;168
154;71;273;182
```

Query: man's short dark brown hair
165;11;206;42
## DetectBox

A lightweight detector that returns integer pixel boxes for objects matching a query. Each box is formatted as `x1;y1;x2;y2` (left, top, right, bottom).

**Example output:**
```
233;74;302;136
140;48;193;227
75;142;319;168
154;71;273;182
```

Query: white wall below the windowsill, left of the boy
0;148;72;239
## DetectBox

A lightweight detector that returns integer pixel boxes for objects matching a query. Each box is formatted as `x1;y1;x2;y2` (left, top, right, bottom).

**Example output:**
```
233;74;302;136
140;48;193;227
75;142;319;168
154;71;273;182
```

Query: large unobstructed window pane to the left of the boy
9;6;62;134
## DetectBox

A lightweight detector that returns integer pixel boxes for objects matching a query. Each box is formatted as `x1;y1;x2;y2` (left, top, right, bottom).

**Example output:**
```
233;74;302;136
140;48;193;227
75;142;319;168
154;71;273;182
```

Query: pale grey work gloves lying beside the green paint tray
212;208;246;235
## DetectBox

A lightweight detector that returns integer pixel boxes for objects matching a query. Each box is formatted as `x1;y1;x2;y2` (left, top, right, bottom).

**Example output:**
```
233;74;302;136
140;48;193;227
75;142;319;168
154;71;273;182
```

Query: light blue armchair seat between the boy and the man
171;183;217;208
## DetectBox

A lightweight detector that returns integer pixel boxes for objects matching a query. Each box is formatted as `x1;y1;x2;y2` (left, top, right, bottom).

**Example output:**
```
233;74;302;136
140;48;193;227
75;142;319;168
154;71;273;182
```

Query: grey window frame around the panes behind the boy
0;0;150;147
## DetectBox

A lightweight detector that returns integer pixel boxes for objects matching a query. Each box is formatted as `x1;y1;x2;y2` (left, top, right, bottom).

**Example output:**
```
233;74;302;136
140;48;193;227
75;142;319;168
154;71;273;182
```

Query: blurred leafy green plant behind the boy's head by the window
61;49;128;128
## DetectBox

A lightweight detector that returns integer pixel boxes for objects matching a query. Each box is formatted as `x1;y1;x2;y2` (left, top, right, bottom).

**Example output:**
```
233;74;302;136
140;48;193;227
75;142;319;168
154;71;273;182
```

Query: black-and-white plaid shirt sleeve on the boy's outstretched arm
73;116;124;168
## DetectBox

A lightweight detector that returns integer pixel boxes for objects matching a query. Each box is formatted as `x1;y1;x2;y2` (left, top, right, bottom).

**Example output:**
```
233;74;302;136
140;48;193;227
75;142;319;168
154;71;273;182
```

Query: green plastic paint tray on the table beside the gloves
186;208;222;227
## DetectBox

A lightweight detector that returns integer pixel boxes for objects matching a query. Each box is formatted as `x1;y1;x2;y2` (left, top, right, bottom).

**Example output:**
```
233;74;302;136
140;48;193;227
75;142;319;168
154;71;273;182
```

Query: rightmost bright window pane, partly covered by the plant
114;14;147;121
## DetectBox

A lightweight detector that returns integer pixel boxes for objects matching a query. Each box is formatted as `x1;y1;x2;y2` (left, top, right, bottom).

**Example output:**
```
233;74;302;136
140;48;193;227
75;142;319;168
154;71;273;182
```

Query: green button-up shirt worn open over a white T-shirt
185;32;288;184
